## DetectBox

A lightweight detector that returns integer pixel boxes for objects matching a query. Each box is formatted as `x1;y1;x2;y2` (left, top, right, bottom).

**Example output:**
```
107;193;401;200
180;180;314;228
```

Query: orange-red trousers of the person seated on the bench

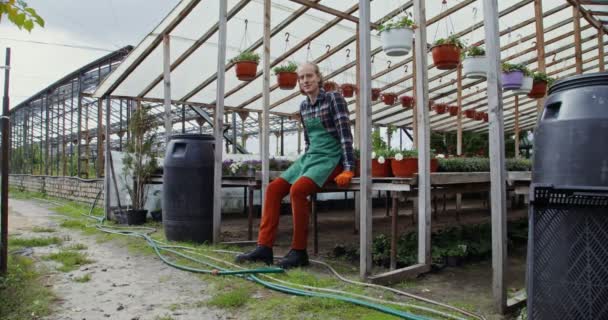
258;165;342;250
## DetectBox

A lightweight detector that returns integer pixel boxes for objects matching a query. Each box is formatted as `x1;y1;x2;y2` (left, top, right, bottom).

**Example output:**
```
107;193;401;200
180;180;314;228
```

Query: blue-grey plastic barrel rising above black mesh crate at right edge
532;72;608;187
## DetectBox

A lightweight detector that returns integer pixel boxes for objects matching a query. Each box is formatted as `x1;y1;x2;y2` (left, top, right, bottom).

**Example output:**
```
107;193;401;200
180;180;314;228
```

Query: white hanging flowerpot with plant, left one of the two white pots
378;15;414;57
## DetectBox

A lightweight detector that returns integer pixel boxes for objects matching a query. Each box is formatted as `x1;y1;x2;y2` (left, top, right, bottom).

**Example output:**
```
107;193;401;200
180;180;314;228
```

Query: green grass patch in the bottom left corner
0;255;54;320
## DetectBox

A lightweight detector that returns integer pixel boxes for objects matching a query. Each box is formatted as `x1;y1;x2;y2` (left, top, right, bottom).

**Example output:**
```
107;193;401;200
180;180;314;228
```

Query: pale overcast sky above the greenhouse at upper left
0;0;179;107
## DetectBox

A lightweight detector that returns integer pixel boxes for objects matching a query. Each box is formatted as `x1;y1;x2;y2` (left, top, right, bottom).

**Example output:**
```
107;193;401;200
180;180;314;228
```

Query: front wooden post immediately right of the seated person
357;0;372;279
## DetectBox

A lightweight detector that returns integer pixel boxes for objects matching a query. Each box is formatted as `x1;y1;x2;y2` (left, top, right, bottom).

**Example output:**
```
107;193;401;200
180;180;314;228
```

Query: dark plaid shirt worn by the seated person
300;89;355;171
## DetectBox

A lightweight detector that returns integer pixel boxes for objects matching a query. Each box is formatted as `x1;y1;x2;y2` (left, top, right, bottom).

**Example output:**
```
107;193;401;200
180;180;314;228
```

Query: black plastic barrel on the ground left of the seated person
163;134;215;243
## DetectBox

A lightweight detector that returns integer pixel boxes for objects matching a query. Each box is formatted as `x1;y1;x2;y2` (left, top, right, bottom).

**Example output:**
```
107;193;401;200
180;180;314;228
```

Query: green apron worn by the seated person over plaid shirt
281;118;342;187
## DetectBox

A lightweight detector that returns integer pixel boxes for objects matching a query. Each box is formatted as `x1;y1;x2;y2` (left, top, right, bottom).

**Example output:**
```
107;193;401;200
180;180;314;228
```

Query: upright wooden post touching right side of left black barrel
213;0;228;243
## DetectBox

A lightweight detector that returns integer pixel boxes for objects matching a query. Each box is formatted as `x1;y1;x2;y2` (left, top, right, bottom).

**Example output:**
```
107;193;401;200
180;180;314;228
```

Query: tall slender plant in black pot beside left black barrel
116;107;158;225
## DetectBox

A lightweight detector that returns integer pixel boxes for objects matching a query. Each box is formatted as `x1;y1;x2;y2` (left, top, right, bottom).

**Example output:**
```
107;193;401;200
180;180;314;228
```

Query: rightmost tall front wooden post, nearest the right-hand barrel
483;0;507;314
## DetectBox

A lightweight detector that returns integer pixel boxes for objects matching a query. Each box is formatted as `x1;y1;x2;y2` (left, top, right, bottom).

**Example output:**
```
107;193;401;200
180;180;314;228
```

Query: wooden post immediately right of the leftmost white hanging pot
414;0;431;266
